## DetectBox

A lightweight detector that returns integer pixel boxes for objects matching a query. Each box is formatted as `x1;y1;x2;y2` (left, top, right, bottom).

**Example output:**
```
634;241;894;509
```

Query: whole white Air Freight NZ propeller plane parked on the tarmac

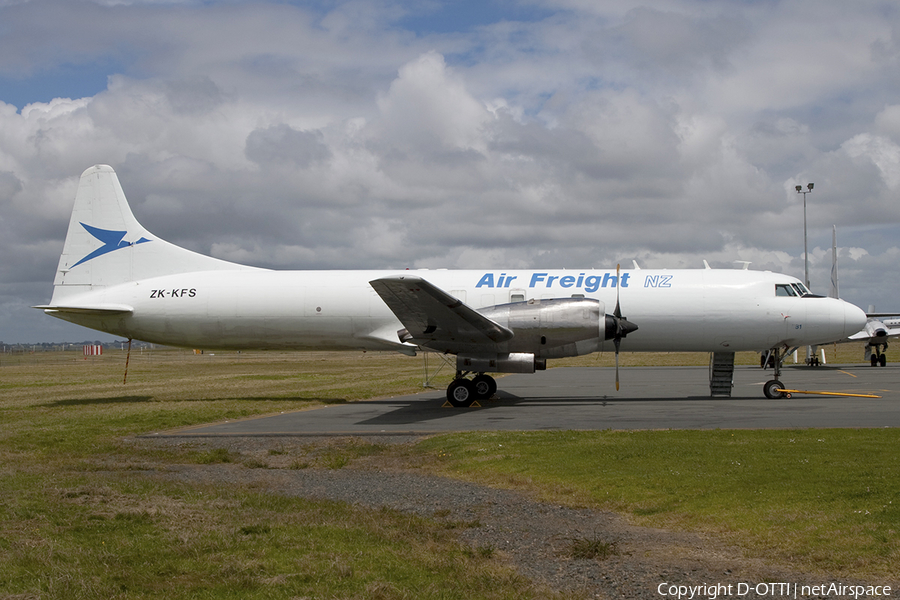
35;165;866;406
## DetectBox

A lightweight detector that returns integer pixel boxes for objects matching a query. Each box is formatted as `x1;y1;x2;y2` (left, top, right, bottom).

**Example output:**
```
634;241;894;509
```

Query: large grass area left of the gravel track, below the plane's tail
0;351;568;599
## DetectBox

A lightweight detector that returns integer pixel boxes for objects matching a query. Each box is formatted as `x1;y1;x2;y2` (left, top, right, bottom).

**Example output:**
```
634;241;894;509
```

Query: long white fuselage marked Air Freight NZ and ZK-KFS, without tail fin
54;269;864;352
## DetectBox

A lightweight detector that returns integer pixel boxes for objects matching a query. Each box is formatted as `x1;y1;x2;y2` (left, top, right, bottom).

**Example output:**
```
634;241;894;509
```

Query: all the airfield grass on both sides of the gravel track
0;346;900;598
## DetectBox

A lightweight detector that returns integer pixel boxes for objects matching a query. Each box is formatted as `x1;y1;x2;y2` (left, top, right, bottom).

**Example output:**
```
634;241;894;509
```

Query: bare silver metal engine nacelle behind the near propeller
472;298;616;358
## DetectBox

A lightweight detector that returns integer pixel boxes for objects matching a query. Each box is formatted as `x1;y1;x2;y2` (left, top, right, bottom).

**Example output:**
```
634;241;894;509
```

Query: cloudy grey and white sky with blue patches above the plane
0;0;900;344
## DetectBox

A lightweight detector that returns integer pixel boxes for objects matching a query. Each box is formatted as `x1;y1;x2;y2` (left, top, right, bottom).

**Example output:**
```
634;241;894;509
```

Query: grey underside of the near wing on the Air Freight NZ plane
369;275;513;352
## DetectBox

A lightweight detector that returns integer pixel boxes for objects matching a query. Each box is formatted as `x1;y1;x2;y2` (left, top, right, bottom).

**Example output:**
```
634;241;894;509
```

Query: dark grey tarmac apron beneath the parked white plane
149;365;900;437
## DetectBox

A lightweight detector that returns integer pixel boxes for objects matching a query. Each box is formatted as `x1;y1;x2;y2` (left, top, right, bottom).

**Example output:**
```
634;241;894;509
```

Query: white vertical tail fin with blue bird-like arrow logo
52;165;253;303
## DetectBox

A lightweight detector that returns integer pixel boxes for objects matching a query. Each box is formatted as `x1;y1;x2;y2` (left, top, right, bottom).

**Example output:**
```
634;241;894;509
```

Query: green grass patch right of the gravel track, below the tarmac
416;429;900;578
